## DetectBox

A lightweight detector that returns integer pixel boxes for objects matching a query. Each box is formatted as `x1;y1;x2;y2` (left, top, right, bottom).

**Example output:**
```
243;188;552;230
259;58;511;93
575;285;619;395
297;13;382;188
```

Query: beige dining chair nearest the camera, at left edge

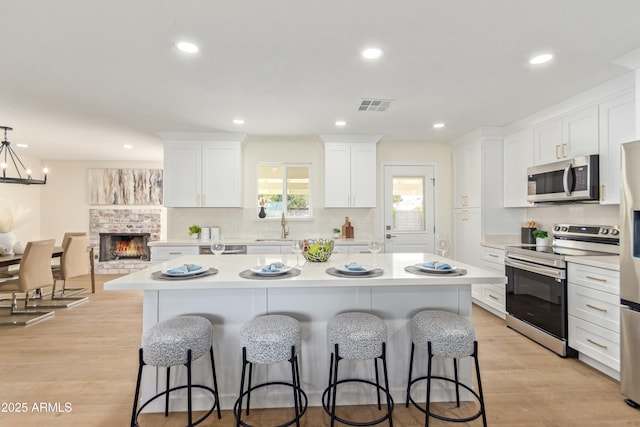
0;239;55;325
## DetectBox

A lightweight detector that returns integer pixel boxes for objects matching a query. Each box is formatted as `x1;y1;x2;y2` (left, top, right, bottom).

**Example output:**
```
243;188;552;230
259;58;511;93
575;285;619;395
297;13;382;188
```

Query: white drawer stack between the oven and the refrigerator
567;263;620;379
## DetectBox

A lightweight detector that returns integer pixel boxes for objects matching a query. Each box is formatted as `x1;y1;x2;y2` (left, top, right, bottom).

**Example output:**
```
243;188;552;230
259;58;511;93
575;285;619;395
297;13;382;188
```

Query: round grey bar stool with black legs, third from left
322;312;393;427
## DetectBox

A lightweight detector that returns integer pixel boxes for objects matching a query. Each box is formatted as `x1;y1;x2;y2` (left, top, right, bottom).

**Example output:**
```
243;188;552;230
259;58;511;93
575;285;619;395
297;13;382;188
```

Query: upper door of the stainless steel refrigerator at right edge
620;141;640;304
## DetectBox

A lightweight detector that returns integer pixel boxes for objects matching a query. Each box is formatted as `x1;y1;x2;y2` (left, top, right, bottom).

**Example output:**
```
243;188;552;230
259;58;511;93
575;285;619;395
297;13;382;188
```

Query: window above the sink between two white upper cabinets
258;163;311;219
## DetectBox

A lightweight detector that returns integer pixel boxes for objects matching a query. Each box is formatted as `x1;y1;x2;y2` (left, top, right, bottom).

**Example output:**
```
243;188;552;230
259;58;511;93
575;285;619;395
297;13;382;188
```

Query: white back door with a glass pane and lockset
382;165;435;252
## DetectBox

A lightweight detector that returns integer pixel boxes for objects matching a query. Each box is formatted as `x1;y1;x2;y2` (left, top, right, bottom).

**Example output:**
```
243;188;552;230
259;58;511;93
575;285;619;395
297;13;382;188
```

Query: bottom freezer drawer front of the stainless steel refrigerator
620;309;640;403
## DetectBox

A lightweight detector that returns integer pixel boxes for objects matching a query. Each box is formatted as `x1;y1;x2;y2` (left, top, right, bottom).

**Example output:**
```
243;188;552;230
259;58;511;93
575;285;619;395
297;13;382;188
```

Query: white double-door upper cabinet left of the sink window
164;134;243;207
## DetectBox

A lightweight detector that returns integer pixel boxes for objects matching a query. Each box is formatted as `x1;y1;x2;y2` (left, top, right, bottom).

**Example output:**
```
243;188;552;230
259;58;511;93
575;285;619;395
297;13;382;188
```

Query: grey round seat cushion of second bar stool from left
240;314;302;364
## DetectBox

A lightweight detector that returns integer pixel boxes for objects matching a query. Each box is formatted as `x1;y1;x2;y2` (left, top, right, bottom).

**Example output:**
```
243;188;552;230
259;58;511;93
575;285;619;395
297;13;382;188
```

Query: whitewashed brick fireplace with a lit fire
89;209;161;274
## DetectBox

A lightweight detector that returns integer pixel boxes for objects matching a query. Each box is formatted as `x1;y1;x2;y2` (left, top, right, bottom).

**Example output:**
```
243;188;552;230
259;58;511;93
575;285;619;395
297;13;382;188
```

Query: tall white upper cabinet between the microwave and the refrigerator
599;90;636;204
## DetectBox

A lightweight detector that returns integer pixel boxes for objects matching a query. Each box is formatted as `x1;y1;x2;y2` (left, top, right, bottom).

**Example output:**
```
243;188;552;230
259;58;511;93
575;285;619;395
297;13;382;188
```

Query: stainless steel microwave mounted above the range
527;154;600;202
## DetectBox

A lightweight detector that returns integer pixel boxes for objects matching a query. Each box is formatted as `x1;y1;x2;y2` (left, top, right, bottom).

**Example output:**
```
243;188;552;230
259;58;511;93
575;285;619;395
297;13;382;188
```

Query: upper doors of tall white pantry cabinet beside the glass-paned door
453;140;482;208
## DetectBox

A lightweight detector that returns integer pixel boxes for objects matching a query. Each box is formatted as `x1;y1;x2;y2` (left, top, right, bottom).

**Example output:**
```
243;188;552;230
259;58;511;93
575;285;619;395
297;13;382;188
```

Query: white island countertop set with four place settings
104;253;506;290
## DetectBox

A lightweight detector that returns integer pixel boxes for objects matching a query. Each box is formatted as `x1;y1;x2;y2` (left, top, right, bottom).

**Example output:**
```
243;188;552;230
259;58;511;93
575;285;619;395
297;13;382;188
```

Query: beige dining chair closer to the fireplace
51;233;89;300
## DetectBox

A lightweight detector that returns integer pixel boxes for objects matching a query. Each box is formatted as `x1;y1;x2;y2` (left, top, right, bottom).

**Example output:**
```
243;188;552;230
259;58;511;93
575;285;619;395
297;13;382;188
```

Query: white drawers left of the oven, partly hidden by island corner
471;247;506;319
